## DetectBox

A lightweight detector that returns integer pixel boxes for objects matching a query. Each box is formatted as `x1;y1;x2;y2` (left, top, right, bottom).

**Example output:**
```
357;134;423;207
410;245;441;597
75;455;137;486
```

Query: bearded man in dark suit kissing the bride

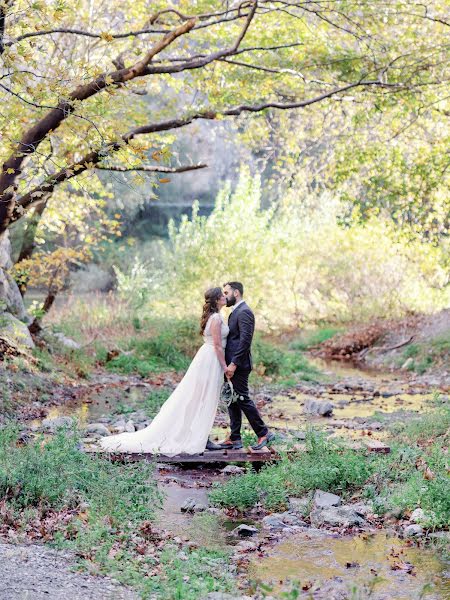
219;281;274;450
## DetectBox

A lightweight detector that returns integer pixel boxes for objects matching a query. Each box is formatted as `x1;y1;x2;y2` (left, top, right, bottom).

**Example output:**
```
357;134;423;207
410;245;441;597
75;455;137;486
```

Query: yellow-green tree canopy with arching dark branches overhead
0;0;450;232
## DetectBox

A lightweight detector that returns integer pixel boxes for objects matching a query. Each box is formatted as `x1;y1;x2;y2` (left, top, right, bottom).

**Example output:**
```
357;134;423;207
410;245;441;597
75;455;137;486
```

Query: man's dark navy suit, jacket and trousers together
225;302;267;441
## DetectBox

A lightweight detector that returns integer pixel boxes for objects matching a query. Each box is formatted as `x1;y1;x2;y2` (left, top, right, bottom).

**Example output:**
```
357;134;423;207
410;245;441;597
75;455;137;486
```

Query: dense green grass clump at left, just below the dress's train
0;426;158;521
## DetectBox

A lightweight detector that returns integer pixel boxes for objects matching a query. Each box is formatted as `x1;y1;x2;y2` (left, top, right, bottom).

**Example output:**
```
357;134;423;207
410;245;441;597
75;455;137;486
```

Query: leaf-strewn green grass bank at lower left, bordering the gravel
0;425;234;600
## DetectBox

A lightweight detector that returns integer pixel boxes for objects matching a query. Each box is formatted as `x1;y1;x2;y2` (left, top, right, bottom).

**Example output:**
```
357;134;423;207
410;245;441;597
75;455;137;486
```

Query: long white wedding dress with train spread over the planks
100;313;229;456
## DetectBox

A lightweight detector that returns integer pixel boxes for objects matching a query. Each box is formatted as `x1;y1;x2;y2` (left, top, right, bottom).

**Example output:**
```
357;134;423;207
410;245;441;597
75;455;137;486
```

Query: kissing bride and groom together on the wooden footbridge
100;281;274;456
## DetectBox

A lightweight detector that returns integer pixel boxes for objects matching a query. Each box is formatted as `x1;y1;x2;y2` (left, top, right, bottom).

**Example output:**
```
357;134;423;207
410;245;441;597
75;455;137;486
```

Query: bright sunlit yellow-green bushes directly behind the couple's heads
148;169;450;328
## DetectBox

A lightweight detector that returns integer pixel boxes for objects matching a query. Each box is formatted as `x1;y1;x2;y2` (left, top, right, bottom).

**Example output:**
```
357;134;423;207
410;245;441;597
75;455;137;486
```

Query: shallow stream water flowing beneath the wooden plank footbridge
22;361;450;600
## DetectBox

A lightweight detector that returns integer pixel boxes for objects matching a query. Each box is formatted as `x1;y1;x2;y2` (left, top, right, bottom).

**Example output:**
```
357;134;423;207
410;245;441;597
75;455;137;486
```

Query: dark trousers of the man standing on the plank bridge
228;367;268;441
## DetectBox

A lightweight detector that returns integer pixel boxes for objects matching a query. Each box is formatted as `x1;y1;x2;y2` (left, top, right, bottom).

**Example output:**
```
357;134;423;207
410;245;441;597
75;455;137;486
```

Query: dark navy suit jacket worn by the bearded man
225;302;255;371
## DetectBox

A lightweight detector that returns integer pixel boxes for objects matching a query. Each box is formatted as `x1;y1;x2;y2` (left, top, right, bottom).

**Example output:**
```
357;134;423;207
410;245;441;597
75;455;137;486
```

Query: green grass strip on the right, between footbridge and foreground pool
210;406;450;528
